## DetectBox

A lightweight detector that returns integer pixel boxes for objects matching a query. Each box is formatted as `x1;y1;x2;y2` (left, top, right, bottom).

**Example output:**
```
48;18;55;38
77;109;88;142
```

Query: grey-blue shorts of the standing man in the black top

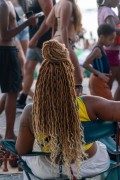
26;48;42;63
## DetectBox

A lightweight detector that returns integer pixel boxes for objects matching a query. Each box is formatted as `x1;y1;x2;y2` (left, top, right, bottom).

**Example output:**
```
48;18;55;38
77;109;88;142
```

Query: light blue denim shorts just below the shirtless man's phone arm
16;19;29;41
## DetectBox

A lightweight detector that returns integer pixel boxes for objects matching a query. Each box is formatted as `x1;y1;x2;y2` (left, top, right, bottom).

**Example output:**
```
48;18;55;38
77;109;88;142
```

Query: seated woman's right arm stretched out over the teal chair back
83;96;120;122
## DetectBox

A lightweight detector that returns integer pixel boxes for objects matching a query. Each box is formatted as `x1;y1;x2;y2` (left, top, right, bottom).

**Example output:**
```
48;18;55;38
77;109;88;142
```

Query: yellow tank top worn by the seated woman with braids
39;97;93;152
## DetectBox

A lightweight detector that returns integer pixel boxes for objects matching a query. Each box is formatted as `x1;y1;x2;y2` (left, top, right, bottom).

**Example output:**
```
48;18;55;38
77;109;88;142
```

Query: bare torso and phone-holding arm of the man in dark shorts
0;0;37;46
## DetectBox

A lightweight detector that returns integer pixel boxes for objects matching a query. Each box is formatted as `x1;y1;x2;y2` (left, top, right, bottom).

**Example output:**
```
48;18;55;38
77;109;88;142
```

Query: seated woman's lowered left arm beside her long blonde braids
16;105;34;155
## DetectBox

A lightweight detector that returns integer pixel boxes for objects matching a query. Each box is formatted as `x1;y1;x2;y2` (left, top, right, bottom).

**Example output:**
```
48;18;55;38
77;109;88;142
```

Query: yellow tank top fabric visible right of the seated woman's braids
77;97;93;151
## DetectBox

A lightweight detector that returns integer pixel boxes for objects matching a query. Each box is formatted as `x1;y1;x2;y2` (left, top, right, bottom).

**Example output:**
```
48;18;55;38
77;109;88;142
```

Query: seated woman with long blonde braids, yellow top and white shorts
16;40;120;178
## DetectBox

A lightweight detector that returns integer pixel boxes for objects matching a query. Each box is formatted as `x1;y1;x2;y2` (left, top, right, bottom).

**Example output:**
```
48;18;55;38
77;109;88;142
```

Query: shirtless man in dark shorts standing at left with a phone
0;0;37;139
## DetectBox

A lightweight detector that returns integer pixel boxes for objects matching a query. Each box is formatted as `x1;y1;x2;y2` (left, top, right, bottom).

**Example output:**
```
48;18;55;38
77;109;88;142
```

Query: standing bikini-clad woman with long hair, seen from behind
46;0;82;87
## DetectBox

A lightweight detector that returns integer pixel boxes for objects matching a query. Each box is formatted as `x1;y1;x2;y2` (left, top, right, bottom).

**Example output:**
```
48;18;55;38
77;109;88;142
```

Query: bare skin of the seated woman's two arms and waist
16;96;120;157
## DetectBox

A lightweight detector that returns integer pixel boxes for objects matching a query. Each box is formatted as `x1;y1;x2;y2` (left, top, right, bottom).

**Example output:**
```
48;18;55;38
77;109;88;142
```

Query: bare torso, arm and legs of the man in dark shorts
0;0;36;139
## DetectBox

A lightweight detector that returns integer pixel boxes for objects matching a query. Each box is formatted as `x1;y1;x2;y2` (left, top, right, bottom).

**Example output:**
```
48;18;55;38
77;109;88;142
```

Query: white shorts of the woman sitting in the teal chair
23;141;110;180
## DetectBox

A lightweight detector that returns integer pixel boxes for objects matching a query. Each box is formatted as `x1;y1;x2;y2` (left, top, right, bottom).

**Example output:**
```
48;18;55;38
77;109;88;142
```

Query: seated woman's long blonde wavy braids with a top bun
32;40;85;177
